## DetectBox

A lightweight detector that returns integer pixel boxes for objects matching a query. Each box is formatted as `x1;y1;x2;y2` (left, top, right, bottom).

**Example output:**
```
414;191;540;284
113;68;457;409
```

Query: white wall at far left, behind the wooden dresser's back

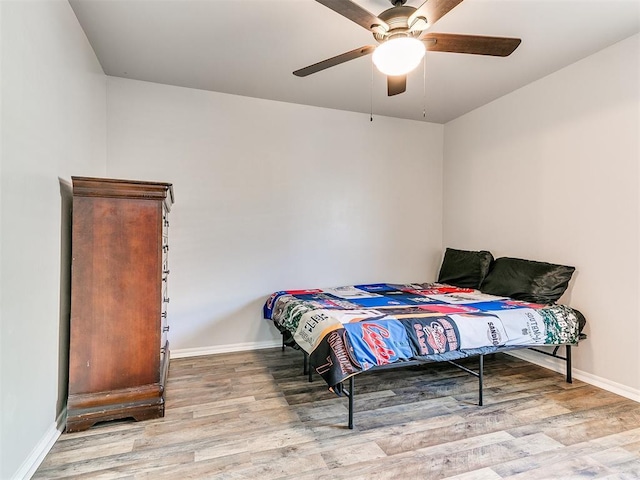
0;0;106;479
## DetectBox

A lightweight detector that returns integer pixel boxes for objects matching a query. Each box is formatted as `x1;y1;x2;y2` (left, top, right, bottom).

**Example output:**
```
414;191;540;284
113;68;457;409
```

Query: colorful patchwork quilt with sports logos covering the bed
264;283;581;387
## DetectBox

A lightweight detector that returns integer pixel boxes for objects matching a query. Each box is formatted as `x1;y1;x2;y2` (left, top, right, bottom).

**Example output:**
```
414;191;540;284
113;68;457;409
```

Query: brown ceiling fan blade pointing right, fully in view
420;33;521;57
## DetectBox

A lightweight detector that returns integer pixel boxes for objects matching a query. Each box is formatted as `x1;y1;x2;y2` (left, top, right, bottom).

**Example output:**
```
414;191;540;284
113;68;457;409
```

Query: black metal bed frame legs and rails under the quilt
282;334;586;430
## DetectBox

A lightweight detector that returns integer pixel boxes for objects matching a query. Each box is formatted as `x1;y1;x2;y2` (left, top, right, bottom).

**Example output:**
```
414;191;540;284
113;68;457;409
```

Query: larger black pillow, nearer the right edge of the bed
480;257;575;304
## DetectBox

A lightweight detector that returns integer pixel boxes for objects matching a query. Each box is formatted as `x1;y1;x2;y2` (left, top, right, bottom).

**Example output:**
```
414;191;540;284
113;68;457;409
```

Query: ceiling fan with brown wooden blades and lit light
293;0;521;96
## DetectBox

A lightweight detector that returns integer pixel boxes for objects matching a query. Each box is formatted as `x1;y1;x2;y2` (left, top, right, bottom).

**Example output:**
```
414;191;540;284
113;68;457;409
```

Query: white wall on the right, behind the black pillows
444;35;640;399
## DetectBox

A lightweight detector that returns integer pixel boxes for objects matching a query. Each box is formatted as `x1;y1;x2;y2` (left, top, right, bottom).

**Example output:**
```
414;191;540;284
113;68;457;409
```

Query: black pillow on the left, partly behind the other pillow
438;248;493;288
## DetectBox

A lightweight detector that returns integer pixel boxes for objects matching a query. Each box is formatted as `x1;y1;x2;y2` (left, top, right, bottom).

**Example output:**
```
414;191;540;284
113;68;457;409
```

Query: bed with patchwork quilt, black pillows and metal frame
264;249;586;428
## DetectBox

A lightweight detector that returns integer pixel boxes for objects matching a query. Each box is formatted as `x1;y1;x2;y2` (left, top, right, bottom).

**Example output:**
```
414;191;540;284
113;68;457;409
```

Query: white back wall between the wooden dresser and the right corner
107;78;443;353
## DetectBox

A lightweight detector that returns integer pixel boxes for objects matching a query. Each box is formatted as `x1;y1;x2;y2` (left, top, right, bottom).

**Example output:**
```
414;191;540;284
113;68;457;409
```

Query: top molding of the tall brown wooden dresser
71;177;174;210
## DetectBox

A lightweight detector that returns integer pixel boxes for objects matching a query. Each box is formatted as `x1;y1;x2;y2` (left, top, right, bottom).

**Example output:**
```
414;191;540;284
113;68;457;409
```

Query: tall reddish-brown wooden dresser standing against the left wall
66;177;173;432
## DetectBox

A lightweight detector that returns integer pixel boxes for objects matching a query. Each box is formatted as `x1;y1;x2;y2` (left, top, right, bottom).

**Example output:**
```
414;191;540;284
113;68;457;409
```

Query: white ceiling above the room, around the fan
69;0;640;123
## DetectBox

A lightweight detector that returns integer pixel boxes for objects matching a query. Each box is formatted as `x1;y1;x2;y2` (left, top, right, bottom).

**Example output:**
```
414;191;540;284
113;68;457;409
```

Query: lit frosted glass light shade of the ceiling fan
373;37;425;75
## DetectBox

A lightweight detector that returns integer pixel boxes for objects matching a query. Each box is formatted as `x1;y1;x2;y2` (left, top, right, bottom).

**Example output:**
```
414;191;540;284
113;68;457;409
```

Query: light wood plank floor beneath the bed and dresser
34;349;640;480
